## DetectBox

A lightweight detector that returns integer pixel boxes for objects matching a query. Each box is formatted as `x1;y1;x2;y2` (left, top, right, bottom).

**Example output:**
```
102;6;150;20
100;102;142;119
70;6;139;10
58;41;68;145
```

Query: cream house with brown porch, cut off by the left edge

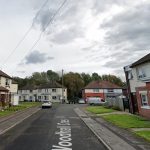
0;70;18;105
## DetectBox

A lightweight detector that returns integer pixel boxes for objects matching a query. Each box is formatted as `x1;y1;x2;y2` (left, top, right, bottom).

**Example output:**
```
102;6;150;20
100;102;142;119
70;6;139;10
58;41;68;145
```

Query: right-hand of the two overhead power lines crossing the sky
11;0;67;75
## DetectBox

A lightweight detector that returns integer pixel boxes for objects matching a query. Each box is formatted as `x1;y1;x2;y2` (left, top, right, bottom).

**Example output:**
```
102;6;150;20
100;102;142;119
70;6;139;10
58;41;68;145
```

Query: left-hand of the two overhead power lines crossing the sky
2;0;49;65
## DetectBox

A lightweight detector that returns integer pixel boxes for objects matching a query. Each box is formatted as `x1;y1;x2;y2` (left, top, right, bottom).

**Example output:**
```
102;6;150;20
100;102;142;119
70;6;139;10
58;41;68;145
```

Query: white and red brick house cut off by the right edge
124;54;150;119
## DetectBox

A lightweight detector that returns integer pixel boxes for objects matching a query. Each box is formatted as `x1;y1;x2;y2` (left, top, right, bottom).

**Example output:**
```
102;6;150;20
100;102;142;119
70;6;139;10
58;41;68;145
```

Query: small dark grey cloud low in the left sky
25;50;54;64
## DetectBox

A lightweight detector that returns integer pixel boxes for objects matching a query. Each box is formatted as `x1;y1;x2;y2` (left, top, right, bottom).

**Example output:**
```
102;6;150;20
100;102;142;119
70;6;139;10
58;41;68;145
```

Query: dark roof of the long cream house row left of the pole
19;81;65;90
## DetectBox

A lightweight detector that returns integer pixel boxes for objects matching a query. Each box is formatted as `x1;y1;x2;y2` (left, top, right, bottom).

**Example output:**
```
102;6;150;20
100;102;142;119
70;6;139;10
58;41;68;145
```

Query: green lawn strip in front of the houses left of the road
0;102;41;117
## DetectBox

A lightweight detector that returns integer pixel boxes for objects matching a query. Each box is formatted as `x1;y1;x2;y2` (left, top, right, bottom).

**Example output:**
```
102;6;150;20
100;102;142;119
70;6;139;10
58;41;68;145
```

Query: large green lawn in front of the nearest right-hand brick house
102;114;150;128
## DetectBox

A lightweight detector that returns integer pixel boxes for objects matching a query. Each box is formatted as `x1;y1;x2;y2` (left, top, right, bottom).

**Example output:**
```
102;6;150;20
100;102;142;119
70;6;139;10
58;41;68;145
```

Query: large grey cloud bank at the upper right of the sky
100;3;150;51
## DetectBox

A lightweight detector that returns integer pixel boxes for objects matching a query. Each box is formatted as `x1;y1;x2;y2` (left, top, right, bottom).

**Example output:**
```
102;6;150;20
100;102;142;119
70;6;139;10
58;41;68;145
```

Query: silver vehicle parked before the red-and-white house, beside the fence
88;97;105;105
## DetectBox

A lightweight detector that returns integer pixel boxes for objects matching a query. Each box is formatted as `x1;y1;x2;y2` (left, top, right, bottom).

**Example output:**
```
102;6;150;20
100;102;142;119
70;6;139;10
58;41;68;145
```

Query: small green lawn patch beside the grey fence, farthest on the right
86;106;116;114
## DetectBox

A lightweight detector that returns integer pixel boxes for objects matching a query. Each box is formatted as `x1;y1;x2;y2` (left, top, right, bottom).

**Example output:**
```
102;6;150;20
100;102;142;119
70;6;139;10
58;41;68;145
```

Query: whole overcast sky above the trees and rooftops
0;0;150;78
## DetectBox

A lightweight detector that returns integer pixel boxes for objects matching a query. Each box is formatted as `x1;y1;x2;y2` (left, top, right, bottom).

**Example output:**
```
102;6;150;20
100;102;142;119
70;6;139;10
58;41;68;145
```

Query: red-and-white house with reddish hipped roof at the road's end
82;81;122;100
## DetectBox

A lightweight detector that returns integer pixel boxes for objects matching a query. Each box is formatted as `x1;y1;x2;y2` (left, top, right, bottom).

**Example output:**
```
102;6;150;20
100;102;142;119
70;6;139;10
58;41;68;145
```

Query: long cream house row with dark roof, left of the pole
18;81;67;102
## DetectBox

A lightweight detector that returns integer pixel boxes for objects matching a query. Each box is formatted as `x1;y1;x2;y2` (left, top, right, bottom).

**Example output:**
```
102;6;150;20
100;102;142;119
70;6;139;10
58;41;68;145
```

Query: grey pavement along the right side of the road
75;108;150;150
